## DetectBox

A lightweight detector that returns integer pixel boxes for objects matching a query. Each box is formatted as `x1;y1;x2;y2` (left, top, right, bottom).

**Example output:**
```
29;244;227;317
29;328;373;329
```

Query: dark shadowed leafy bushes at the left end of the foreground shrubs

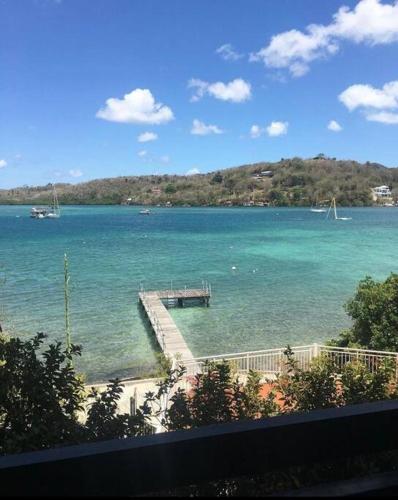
0;333;152;454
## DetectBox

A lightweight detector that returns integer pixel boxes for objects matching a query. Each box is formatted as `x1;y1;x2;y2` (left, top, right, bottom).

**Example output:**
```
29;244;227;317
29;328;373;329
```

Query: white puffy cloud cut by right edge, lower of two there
339;80;398;111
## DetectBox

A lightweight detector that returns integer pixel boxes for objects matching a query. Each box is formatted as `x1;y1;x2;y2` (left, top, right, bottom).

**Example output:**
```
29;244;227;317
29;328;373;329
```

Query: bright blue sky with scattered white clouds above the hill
0;0;398;189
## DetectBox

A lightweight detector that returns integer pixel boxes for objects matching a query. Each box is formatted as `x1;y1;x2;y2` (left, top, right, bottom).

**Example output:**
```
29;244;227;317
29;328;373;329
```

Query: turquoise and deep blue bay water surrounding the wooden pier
0;206;398;381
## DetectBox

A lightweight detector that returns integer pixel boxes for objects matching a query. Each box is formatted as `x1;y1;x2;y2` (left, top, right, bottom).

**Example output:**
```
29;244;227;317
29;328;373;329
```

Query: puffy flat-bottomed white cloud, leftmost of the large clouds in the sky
96;89;174;125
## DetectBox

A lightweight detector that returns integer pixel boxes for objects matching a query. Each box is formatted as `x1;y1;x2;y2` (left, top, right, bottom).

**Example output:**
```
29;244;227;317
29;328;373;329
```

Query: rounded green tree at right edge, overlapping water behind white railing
332;273;398;351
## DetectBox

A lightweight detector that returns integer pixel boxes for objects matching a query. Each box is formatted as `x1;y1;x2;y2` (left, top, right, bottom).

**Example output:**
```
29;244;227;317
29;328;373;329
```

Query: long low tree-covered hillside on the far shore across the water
0;155;398;206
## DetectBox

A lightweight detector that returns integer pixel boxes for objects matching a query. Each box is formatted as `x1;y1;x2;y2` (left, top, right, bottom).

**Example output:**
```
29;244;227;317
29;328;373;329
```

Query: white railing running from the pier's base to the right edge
184;344;398;376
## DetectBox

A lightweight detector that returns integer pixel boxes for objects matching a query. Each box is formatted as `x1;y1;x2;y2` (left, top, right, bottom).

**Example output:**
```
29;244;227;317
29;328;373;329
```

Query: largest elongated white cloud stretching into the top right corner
249;0;398;77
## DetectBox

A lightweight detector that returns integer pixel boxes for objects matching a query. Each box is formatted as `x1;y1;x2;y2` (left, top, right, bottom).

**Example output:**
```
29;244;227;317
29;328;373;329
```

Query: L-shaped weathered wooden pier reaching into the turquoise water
138;286;211;361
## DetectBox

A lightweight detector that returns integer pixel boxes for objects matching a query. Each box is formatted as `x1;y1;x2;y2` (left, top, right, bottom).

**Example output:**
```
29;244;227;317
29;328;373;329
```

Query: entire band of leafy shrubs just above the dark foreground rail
0;333;396;454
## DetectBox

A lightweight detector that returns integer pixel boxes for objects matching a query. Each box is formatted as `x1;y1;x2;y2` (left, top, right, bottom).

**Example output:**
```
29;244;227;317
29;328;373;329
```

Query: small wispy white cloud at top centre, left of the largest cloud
188;78;251;102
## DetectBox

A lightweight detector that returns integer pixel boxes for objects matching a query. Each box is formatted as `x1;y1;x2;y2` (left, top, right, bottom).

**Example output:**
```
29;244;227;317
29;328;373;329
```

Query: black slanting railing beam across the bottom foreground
0;401;398;496
